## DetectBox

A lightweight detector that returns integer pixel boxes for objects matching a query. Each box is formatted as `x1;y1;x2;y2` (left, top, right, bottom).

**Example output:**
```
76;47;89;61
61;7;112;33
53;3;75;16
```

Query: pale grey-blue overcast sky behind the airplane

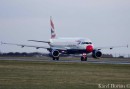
0;0;130;54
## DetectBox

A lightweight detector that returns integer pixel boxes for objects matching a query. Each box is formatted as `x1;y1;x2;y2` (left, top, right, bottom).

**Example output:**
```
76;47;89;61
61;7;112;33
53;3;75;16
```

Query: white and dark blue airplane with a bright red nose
1;17;128;61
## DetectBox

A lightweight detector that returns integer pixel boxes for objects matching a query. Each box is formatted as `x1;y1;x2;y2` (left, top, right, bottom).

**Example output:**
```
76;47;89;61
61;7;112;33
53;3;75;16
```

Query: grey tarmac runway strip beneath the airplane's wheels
0;57;130;64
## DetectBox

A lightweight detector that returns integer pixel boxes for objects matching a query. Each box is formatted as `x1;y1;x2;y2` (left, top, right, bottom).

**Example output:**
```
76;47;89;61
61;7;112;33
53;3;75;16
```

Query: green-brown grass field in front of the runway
0;61;130;89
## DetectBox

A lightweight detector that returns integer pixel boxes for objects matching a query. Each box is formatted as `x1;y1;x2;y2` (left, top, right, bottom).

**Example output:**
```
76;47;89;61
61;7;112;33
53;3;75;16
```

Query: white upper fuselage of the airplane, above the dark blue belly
50;38;93;49
